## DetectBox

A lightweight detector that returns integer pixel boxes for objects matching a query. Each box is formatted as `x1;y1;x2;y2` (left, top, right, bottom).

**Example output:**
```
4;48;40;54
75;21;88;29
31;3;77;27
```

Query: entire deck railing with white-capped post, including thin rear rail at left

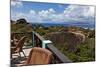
11;31;72;64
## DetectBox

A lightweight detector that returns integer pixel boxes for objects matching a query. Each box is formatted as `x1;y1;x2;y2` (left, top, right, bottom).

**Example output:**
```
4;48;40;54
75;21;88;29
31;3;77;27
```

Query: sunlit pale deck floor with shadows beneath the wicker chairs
11;47;32;67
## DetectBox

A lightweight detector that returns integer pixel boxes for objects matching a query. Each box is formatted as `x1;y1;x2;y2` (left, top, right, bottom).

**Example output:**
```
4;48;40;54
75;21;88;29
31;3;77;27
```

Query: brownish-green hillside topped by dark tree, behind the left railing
11;19;33;32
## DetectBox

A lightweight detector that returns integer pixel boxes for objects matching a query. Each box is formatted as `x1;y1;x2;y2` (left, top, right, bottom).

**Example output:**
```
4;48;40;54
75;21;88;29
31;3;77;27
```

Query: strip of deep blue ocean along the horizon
33;23;95;29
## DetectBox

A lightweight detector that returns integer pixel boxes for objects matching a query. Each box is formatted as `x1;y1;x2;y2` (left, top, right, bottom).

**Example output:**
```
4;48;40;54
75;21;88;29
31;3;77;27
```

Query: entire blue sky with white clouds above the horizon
11;1;95;24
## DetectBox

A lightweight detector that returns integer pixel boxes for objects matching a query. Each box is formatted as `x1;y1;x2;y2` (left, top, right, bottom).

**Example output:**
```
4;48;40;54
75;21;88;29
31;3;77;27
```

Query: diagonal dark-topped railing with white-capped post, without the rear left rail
34;32;72;63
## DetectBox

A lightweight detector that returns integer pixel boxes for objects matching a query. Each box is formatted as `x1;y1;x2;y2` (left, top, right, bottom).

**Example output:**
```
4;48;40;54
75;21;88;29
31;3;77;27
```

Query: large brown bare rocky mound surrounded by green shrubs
46;32;85;51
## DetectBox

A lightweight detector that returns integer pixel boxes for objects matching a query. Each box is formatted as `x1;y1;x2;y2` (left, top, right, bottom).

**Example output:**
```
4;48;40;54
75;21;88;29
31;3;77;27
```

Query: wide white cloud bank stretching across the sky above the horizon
12;5;95;22
